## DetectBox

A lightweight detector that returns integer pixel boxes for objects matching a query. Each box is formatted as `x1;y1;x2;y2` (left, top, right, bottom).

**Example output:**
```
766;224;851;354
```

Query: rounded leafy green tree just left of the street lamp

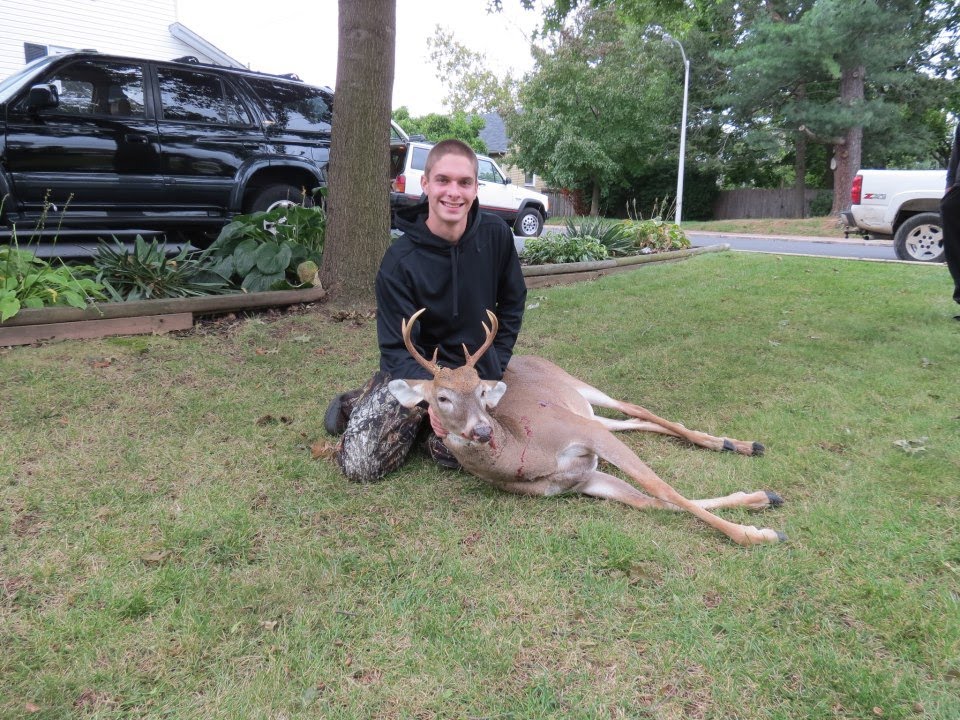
504;8;682;215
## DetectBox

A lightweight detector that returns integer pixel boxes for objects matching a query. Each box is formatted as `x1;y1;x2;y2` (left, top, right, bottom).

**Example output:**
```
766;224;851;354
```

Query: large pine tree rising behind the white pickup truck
718;0;958;212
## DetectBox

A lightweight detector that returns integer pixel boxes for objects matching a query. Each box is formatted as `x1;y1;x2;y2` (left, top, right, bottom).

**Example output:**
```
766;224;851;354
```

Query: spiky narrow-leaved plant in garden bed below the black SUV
94;235;229;302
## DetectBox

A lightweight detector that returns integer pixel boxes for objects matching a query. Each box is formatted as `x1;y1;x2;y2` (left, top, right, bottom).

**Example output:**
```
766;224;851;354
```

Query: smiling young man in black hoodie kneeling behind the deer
324;140;527;482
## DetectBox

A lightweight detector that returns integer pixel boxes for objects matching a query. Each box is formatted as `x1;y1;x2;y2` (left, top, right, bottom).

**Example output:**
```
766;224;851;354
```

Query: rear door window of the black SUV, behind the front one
157;67;252;125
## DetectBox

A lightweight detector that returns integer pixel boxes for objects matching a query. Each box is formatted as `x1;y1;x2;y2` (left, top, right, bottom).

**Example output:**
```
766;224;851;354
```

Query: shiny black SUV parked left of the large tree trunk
0;51;405;242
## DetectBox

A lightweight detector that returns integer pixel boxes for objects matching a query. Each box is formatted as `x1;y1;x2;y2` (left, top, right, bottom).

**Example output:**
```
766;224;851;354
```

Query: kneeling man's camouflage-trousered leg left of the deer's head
334;372;427;482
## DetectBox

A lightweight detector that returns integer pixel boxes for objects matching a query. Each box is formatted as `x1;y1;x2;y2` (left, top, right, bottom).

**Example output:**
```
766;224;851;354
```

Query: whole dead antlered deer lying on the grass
389;310;786;545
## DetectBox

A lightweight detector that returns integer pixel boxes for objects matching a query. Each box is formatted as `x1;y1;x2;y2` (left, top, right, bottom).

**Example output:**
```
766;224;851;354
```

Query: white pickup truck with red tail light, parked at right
840;170;947;262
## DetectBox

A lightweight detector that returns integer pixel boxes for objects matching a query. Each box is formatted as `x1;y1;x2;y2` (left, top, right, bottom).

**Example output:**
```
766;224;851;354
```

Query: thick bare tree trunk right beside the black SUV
320;0;396;309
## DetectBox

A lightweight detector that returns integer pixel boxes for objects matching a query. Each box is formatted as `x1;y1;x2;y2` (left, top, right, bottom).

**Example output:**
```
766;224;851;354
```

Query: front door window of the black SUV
19;60;144;117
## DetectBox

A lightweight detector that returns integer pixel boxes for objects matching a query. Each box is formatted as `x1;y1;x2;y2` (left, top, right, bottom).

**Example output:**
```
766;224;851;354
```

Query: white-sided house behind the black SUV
0;0;244;78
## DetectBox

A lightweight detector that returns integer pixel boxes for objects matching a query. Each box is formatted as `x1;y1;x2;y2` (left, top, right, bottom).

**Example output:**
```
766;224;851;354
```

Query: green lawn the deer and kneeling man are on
0;253;960;720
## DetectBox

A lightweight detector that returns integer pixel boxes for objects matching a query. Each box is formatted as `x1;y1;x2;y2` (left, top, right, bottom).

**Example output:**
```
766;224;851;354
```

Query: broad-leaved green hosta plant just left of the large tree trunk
208;205;327;292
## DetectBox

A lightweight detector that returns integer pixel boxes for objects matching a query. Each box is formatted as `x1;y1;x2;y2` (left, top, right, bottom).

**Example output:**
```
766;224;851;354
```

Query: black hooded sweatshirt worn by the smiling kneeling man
376;200;527;380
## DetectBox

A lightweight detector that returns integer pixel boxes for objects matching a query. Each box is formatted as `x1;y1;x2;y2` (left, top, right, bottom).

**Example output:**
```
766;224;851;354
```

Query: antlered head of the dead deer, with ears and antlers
388;308;507;443
